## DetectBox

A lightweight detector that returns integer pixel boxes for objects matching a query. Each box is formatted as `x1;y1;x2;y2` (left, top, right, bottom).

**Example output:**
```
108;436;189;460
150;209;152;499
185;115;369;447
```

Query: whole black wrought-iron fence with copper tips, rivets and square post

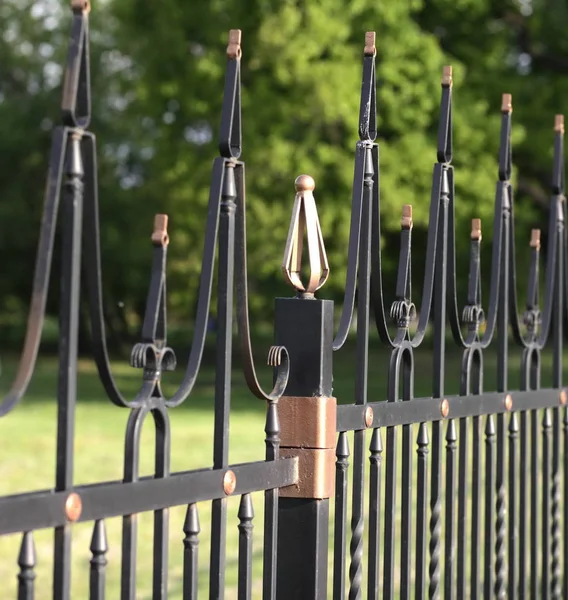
0;0;568;600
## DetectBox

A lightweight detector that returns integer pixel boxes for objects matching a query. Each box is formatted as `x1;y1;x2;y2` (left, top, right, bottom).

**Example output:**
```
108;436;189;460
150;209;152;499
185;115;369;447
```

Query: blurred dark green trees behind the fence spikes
0;0;568;351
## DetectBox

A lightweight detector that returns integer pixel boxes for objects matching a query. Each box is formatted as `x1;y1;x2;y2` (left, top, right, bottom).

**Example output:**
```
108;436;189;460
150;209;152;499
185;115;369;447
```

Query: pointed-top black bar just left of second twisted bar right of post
415;423;430;600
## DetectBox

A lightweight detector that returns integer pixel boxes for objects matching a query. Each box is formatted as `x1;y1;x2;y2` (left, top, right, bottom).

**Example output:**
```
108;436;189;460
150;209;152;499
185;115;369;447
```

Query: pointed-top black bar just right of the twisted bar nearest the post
367;428;383;600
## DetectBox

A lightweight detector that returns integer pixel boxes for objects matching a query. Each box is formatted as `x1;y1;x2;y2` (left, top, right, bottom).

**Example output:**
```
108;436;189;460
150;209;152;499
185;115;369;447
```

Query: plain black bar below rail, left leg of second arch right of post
456;412;466;598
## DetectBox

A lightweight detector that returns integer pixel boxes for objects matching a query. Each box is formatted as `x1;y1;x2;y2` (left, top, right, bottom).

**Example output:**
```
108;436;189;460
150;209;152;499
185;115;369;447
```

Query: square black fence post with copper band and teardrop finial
275;176;336;600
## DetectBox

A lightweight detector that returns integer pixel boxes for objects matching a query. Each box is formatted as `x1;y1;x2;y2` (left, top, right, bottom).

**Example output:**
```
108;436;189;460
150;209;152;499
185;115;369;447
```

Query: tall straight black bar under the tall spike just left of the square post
209;161;237;600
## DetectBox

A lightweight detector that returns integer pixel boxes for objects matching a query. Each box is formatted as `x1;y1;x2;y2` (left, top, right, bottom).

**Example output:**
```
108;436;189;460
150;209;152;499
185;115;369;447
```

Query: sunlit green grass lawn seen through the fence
0;340;564;600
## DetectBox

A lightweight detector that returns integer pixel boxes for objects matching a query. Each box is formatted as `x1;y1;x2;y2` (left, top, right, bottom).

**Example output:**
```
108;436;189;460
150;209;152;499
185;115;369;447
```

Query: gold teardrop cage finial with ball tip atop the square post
282;175;329;296
